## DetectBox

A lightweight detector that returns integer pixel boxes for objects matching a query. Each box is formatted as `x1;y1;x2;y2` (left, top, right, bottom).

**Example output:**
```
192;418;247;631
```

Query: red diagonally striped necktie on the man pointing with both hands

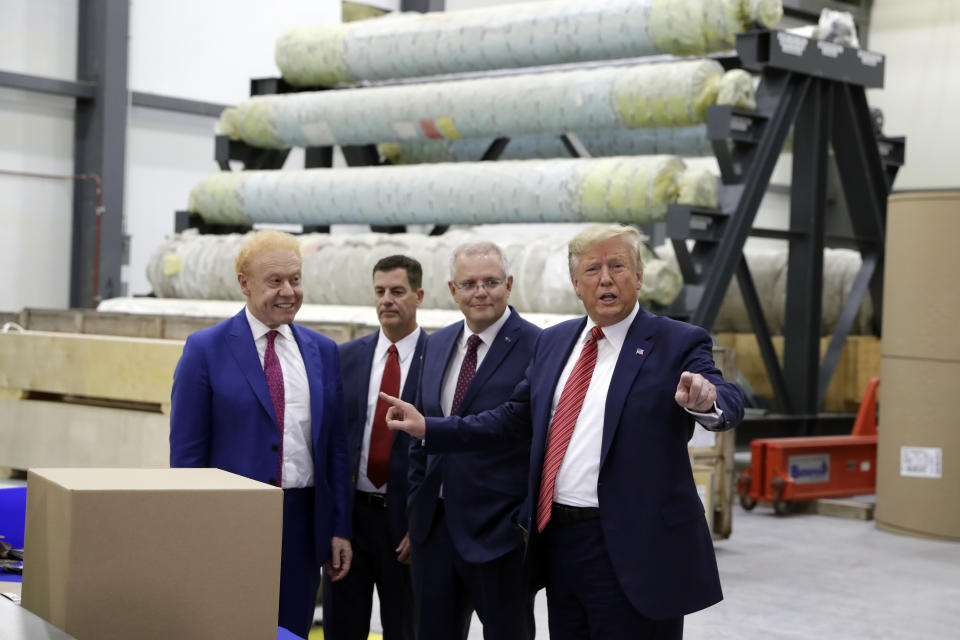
537;327;603;531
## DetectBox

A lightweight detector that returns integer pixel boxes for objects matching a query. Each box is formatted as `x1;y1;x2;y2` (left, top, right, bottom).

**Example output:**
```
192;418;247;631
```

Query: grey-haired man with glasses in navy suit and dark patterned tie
408;242;540;640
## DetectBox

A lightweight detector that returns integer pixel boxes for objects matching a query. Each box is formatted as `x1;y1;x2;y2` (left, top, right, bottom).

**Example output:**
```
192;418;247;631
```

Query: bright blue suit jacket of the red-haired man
170;310;350;563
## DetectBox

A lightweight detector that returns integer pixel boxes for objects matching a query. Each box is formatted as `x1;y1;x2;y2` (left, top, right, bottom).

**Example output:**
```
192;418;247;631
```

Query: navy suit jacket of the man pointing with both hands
426;309;743;619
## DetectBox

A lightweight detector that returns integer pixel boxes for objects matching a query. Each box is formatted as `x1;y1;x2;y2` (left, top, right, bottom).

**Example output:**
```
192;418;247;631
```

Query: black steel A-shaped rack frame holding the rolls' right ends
667;31;905;419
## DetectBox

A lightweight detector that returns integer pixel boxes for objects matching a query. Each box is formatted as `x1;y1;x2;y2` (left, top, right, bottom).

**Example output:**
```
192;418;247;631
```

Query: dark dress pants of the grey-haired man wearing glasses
412;500;535;640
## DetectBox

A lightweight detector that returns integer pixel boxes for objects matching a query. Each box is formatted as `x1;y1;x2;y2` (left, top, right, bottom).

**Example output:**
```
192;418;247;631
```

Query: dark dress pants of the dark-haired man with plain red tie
323;496;414;640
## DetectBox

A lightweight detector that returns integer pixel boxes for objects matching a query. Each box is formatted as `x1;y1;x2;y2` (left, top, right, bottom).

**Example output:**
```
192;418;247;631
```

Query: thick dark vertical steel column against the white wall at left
70;0;130;307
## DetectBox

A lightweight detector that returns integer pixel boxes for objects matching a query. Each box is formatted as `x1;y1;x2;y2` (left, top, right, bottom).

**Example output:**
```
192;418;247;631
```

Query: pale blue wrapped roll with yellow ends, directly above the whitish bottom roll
189;156;716;225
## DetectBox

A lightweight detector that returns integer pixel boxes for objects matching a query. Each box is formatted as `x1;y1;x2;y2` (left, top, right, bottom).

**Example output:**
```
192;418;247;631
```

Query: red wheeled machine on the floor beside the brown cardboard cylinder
737;378;880;515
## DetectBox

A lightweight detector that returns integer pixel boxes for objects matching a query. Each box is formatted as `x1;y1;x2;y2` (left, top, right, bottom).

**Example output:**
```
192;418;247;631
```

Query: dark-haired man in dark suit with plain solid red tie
323;255;427;640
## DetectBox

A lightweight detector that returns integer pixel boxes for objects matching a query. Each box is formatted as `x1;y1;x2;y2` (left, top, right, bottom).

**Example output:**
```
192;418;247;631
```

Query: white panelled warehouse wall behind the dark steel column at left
0;0;340;310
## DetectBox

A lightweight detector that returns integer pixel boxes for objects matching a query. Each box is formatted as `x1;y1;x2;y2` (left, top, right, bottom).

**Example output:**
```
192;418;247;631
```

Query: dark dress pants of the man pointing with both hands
541;518;683;640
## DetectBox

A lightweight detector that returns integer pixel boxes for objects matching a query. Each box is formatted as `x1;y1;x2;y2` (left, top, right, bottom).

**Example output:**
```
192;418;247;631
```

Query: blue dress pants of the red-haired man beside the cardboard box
278;487;320;638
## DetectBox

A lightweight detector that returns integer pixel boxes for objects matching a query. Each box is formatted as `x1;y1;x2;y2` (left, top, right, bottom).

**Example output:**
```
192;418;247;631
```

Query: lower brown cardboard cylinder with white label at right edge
876;357;960;540
